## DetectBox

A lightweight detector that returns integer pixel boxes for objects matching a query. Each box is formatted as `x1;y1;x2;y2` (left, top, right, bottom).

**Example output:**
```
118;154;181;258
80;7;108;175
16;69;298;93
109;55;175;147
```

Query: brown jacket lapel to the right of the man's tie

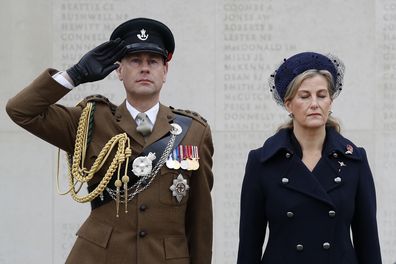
145;104;175;147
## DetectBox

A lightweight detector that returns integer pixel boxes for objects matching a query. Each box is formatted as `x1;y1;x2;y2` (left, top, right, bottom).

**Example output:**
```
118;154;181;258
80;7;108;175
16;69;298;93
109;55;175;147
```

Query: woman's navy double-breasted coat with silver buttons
238;129;381;264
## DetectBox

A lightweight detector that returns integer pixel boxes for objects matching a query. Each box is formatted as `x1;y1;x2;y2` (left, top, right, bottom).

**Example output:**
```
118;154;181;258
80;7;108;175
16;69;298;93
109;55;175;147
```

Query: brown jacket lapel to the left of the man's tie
114;101;145;146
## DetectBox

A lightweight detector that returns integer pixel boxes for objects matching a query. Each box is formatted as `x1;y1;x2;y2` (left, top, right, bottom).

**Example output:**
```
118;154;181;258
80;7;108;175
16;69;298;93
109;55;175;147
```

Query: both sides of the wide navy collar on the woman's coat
260;127;361;162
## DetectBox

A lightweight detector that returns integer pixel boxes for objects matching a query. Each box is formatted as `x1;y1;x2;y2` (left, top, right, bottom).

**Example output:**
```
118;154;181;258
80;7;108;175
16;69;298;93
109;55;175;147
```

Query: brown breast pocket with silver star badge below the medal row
160;168;191;206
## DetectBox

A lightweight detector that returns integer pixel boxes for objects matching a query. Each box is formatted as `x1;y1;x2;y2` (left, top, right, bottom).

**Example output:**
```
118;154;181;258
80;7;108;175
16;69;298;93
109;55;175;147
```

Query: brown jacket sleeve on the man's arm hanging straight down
186;126;214;264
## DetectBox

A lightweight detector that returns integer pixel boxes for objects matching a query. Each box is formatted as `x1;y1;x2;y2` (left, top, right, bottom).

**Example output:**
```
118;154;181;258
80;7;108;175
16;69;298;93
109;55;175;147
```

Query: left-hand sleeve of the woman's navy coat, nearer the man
237;151;267;264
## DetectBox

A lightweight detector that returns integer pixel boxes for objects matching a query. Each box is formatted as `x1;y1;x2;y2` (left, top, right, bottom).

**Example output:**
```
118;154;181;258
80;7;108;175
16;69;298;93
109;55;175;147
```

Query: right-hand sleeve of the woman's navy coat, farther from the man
352;148;382;264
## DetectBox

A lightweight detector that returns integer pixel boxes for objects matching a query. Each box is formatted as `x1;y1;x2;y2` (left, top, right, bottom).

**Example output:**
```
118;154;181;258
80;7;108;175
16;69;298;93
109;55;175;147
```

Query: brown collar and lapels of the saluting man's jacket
114;101;175;147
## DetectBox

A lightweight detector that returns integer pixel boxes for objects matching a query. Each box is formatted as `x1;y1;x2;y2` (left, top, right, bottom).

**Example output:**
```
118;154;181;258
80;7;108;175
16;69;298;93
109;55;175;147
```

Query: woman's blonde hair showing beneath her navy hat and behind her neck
278;70;341;132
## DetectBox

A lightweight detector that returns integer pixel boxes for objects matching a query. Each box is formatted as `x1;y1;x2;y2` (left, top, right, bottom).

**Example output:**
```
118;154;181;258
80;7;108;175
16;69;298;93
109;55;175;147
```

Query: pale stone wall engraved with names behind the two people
0;0;396;264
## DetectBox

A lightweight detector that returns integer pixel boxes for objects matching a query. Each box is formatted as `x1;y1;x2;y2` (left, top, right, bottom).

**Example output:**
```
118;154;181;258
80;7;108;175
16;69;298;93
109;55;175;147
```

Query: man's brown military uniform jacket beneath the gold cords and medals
7;69;213;264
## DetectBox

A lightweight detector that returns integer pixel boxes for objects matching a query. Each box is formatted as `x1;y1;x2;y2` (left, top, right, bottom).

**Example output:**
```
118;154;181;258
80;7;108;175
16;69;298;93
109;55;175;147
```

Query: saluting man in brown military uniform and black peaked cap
7;18;213;264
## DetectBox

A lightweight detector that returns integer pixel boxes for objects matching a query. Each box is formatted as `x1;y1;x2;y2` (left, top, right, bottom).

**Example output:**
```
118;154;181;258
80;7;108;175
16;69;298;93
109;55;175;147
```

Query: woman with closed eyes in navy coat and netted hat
238;52;381;264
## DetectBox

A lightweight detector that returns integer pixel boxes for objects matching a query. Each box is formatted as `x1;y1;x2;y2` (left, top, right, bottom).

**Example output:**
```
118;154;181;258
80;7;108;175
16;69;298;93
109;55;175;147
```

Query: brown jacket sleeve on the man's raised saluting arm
6;69;81;152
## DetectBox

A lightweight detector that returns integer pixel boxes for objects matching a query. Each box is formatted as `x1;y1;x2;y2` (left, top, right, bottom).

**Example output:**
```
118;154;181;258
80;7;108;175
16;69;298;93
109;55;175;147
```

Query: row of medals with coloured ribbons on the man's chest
166;145;199;170
